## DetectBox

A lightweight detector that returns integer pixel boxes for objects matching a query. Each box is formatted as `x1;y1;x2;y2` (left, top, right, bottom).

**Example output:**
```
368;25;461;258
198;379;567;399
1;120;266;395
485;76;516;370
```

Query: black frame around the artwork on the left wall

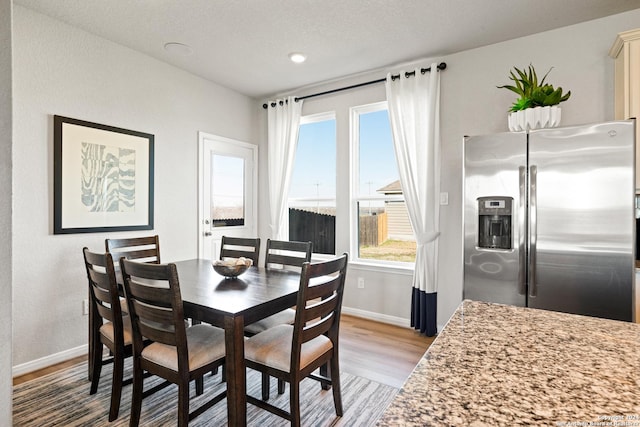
53;115;154;234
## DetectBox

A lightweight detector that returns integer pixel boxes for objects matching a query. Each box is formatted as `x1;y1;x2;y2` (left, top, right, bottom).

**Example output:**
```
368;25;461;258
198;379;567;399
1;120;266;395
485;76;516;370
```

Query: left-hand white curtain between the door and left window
267;96;302;240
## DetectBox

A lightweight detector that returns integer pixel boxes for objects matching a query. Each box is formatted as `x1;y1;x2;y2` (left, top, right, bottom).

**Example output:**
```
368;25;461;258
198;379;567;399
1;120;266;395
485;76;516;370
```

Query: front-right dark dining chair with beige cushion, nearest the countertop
244;253;348;426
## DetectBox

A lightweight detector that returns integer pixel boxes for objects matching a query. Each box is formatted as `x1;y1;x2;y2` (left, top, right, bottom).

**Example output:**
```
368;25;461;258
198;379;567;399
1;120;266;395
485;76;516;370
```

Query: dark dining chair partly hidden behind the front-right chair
244;239;313;400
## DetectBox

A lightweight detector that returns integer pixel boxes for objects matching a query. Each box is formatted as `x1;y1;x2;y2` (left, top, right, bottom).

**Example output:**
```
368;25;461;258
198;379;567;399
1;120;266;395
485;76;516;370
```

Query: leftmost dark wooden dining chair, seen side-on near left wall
82;247;133;421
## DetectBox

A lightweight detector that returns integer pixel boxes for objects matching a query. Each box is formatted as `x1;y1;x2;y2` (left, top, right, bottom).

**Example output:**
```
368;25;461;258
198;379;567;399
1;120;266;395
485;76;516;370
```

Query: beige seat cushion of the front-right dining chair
244;325;333;372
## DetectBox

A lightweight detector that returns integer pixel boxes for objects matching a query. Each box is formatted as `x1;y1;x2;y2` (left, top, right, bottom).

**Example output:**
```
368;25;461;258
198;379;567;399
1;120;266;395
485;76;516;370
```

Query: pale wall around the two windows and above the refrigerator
260;9;640;326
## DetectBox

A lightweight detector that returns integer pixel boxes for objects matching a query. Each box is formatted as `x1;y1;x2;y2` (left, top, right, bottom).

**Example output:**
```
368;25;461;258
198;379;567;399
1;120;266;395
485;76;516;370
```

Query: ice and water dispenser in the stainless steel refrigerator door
477;197;513;249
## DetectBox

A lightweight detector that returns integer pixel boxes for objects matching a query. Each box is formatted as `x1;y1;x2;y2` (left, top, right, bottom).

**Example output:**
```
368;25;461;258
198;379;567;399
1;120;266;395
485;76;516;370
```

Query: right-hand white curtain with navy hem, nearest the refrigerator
386;63;440;336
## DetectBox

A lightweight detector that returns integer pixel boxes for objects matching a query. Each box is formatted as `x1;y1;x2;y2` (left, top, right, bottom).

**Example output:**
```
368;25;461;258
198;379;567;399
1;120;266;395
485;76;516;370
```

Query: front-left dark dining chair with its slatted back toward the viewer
120;258;226;426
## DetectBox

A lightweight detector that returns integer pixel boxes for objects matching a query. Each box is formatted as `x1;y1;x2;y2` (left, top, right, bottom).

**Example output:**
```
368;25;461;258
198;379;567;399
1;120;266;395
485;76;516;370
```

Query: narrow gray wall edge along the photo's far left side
0;0;13;420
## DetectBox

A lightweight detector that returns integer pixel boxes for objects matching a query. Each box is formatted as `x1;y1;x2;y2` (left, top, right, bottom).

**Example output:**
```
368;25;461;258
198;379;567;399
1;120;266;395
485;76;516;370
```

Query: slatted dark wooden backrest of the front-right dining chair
291;253;348;366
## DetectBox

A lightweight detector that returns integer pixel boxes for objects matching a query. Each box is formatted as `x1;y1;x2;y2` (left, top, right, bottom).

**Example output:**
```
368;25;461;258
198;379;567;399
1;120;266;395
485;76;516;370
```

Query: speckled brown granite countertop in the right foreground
378;300;640;427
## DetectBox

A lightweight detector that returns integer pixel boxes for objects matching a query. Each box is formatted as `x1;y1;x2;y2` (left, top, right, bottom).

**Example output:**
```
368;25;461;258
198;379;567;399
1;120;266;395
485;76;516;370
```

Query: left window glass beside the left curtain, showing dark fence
289;113;336;254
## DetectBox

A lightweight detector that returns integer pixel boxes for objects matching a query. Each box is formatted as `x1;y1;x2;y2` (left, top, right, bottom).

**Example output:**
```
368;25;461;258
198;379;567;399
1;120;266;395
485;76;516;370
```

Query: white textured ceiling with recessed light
14;0;640;98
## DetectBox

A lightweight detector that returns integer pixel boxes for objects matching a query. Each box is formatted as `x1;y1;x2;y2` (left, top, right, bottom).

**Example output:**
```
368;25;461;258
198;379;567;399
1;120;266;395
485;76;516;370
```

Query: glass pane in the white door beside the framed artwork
211;154;244;227
